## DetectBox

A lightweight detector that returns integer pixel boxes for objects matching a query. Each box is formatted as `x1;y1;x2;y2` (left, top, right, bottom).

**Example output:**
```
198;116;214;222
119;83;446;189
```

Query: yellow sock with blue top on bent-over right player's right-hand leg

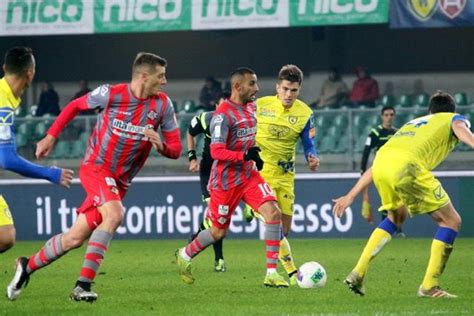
421;227;458;290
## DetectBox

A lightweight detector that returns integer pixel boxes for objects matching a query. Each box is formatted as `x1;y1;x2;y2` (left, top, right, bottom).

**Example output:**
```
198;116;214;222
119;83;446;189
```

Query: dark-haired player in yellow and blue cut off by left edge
0;47;72;253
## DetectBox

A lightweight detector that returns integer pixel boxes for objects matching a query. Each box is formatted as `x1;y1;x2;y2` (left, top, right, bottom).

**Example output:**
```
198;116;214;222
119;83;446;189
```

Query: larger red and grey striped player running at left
10;53;182;301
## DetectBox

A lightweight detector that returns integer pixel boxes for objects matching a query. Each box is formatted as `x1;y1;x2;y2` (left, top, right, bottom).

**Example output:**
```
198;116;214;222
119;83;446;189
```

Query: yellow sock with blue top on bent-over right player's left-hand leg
353;218;397;278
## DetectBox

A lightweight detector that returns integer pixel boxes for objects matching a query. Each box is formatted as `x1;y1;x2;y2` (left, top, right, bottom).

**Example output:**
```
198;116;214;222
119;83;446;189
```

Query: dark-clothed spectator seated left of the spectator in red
311;67;349;108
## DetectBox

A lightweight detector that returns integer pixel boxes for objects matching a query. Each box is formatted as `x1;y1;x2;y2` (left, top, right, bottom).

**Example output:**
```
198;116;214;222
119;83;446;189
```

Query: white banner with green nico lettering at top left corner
0;0;94;36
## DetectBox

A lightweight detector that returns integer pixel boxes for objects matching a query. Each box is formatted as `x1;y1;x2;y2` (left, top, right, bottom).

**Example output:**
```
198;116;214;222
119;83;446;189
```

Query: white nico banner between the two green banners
192;0;289;30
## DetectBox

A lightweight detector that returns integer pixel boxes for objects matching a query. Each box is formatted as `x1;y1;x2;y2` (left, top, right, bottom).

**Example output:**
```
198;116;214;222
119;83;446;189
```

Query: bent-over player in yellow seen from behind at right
333;91;474;298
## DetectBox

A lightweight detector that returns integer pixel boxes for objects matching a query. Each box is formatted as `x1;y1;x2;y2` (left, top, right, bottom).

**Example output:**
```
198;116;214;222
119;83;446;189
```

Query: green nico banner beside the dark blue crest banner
290;0;393;26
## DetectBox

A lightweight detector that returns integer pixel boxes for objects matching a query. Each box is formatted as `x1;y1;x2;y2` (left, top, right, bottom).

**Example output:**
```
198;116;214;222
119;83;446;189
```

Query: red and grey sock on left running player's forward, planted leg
78;229;113;283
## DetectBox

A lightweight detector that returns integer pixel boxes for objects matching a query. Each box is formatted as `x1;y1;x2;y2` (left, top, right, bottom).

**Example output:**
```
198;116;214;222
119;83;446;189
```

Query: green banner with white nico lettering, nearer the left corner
94;0;194;33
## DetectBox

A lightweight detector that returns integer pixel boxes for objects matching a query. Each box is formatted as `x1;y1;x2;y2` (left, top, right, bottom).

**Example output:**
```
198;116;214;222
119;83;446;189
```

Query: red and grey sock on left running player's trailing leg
26;234;67;274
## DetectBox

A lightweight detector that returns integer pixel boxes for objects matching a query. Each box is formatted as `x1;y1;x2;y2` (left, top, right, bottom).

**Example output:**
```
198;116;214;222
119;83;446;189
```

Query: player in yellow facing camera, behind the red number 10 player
247;65;319;284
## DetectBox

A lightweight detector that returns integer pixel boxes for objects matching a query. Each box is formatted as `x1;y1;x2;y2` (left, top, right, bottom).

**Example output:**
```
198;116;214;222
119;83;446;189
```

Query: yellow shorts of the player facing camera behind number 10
260;172;295;216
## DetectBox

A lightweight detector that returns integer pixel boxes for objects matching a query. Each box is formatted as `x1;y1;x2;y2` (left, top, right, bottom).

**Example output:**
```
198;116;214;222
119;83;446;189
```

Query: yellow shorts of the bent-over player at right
372;153;450;215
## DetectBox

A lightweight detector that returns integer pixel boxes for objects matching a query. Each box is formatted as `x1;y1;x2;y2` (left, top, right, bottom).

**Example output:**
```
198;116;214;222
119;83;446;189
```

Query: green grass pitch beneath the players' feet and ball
0;238;474;315
